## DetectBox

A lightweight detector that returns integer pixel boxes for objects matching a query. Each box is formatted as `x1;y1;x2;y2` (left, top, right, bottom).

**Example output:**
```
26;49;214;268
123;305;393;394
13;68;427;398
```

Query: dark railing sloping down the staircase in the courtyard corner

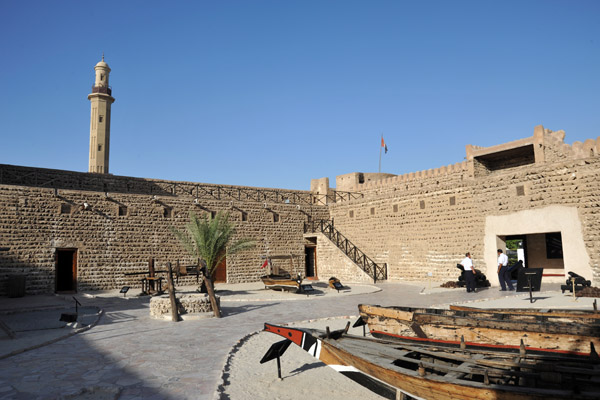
304;220;387;283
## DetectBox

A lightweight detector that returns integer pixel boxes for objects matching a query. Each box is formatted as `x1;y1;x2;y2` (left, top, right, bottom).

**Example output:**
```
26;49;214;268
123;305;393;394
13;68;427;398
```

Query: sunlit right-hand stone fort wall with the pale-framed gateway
330;127;600;284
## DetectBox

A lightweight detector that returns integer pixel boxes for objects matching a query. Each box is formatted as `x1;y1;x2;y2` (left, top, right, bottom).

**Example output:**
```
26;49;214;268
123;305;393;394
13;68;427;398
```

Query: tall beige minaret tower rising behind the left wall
88;54;115;174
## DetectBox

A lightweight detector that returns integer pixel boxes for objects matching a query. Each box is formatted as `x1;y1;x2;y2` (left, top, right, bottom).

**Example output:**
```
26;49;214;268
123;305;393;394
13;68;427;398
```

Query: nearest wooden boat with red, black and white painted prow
265;323;600;400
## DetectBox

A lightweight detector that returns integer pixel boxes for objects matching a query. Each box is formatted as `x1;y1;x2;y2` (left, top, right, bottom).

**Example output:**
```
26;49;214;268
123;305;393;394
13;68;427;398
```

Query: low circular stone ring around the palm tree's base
150;293;220;319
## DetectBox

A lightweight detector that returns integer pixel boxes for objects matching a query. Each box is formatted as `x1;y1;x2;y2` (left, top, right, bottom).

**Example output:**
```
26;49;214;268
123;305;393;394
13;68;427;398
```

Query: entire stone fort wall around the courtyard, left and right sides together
0;127;600;295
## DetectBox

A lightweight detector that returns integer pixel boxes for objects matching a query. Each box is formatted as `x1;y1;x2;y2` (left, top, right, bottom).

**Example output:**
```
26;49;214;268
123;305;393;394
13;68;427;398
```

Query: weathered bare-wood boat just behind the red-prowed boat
358;304;600;354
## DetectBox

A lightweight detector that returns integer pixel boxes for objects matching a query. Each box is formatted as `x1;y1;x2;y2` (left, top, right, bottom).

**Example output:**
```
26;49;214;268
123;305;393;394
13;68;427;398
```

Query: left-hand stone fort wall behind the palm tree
0;165;329;296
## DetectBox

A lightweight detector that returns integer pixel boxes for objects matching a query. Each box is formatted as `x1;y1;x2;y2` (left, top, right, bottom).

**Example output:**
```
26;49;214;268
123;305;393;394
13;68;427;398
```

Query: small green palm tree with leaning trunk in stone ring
171;211;254;318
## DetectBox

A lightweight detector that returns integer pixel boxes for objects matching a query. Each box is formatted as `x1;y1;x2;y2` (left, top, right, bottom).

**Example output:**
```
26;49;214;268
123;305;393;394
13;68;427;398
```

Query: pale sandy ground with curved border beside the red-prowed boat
219;316;381;400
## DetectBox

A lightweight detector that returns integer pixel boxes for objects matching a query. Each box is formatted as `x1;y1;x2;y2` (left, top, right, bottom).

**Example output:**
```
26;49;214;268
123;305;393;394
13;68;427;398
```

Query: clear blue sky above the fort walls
0;0;600;189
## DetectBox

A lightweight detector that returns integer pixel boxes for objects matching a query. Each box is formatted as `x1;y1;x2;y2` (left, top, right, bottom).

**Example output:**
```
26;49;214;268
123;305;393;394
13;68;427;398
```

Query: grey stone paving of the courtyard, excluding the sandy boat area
0;283;576;400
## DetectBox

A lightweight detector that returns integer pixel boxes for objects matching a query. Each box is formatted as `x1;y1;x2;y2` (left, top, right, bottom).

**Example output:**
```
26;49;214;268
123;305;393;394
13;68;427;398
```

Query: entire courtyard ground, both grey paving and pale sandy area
0;282;594;400
